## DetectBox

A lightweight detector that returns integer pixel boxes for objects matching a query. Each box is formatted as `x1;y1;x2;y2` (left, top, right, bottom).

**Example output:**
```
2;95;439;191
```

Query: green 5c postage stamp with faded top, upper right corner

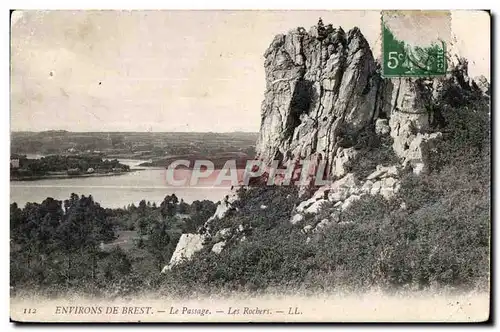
382;10;451;77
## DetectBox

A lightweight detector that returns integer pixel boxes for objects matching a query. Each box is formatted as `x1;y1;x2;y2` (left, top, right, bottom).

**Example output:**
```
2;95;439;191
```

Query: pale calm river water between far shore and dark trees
10;159;230;208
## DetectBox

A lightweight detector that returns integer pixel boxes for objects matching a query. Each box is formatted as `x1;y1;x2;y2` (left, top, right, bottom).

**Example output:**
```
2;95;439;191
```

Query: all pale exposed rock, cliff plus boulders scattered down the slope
164;22;490;271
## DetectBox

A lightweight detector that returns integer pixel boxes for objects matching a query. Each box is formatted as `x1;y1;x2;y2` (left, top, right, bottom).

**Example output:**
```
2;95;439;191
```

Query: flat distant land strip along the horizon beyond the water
11;131;258;161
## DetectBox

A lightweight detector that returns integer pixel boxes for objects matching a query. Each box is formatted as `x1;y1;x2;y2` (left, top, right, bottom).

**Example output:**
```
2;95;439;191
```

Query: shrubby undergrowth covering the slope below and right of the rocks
161;84;491;293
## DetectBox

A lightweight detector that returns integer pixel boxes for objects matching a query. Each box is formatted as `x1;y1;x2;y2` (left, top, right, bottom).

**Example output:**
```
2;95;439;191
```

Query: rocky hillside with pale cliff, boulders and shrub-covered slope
159;22;491;293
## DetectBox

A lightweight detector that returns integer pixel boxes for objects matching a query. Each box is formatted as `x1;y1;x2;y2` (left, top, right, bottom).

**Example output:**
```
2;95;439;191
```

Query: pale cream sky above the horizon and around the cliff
10;10;490;132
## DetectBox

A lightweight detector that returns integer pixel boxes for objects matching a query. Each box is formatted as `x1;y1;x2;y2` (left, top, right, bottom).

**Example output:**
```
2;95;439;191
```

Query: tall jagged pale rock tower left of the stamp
257;27;377;174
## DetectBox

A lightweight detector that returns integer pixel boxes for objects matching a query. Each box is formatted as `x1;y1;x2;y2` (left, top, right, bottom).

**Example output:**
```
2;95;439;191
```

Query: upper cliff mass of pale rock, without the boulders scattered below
257;20;482;178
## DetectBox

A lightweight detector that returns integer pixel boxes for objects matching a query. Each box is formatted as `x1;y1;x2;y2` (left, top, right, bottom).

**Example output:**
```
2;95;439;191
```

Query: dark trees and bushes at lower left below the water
10;194;215;295
